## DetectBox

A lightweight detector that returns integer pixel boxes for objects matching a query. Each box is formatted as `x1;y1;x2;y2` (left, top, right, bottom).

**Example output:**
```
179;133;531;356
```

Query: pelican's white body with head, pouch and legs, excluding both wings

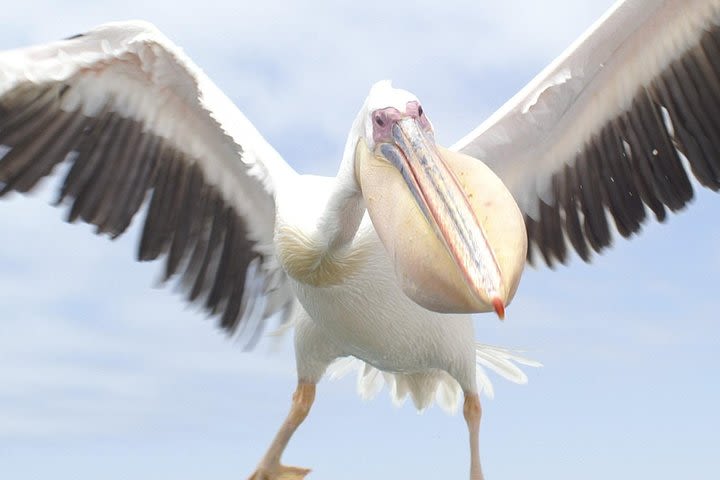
262;87;529;479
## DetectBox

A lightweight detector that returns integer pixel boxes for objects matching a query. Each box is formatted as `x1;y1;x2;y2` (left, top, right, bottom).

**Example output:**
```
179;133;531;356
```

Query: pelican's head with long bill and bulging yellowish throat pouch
354;81;527;318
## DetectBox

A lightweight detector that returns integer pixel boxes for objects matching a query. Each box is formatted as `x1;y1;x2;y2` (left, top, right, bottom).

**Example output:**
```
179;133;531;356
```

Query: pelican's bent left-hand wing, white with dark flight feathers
0;22;294;342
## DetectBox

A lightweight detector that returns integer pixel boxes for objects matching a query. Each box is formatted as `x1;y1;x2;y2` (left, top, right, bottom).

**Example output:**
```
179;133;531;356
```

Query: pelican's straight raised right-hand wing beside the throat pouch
453;0;720;266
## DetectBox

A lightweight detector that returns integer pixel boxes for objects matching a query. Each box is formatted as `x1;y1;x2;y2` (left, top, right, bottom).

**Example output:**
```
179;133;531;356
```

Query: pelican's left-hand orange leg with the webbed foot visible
248;382;315;480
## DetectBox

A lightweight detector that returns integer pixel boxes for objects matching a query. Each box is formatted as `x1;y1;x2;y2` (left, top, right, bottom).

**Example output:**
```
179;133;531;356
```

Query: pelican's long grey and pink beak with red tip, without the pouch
376;118;505;319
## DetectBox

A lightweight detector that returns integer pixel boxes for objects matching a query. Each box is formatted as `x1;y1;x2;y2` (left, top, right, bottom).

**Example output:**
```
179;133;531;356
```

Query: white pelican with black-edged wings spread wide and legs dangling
0;0;720;480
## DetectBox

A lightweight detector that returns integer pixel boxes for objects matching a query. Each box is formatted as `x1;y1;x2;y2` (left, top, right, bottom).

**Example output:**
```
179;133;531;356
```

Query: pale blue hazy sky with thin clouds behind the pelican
0;0;720;480
